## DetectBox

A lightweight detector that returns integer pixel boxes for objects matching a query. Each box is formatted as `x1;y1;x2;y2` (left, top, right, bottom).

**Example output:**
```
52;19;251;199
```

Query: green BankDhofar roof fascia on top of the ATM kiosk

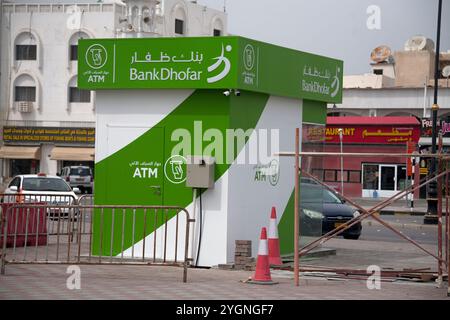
78;36;343;103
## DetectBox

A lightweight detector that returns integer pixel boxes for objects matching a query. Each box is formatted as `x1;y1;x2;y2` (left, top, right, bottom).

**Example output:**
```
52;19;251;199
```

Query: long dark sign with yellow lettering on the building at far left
3;126;95;145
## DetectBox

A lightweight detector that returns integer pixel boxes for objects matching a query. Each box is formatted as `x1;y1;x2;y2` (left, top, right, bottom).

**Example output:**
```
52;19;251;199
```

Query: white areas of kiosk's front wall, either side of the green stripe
96;89;229;265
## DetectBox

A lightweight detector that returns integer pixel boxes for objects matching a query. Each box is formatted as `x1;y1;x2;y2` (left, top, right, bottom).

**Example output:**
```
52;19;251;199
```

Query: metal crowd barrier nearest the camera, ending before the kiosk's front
0;203;194;282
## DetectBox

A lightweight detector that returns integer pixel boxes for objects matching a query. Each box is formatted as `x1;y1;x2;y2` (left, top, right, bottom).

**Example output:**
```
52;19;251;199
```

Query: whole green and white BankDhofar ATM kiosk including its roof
78;36;343;266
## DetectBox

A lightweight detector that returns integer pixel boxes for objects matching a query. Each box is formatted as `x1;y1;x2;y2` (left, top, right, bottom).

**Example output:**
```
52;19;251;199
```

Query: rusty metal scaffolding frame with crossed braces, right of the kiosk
275;128;450;296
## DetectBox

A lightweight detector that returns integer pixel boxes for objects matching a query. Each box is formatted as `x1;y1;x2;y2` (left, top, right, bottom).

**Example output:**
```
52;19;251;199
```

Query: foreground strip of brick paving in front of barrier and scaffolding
0;265;450;300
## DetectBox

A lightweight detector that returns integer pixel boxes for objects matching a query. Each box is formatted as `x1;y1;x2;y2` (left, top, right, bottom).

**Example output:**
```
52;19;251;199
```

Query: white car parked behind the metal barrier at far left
2;173;80;215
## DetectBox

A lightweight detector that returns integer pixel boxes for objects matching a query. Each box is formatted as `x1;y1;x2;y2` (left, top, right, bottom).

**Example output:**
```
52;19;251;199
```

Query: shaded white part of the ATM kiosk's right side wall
227;96;303;262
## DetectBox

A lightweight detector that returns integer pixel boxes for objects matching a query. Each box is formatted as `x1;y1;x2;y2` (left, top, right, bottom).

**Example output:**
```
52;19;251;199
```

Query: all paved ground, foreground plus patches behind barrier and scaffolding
0;196;450;300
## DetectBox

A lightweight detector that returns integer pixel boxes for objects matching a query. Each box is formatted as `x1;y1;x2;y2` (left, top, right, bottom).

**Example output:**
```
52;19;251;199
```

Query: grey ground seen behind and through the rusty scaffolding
301;215;445;272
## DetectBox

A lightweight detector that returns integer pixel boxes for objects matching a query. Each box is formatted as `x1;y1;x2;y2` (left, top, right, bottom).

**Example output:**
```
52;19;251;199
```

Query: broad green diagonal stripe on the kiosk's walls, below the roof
92;90;269;255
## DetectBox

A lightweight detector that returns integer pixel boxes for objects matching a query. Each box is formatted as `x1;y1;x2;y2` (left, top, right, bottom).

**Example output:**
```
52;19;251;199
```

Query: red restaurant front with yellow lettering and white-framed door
320;117;420;198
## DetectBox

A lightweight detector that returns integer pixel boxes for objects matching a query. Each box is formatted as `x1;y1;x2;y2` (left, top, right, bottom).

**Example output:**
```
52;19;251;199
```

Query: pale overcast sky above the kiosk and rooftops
4;0;450;74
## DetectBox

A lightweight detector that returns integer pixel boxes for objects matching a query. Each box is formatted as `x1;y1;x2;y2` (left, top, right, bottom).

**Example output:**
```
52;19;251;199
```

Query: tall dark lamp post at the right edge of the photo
423;0;442;224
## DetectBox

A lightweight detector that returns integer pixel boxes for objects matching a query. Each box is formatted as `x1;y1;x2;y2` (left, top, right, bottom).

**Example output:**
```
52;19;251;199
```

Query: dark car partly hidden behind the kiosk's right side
300;183;362;240
